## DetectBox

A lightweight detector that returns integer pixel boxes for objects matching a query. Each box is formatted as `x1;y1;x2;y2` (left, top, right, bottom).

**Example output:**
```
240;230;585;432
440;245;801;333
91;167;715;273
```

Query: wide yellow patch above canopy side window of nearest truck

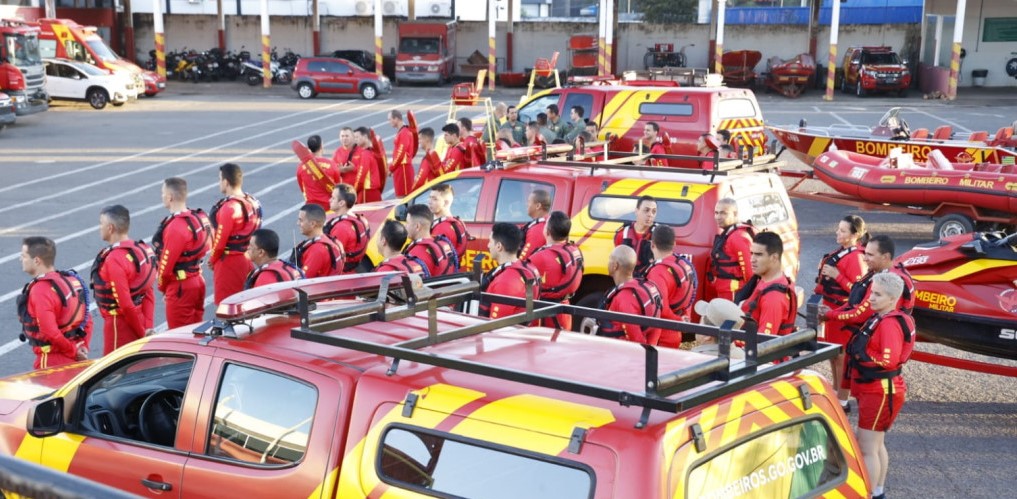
452;394;614;455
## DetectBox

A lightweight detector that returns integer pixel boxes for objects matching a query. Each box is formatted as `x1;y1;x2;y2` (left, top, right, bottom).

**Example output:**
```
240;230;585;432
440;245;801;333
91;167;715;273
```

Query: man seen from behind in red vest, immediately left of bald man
527;211;584;330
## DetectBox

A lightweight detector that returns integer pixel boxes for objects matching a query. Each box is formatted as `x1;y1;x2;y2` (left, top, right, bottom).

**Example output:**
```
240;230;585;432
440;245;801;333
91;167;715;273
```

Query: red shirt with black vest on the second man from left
92;240;156;337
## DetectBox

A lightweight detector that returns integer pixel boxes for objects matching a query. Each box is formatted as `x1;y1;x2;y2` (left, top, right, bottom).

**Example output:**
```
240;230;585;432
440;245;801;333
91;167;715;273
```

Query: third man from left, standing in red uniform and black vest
152;177;209;329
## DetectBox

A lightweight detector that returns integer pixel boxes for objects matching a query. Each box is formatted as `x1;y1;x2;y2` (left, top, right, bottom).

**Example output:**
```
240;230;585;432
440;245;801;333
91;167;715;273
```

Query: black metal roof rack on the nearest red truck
291;267;839;428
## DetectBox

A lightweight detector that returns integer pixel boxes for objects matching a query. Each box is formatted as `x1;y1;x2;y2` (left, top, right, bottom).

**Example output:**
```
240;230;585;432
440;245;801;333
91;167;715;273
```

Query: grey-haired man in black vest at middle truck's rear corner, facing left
705;197;756;301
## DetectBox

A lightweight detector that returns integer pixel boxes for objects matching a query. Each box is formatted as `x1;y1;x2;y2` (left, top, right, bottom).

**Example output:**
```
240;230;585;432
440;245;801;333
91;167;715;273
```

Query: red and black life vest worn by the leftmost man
17;270;92;347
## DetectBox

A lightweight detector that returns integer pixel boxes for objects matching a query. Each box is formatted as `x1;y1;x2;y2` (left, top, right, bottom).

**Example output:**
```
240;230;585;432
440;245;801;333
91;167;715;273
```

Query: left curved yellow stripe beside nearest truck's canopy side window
333;383;484;497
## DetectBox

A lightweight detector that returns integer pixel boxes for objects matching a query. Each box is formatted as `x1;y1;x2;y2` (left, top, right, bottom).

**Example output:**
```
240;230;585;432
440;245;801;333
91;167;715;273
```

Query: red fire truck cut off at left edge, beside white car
0;20;50;116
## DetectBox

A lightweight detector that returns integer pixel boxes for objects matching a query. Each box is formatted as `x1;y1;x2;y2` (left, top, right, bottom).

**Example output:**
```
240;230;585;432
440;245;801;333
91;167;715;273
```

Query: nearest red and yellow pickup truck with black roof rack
0;272;868;499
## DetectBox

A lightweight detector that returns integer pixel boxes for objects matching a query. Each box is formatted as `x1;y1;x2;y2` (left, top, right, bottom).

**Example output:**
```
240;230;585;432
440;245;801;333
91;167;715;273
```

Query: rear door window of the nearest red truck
205;364;317;465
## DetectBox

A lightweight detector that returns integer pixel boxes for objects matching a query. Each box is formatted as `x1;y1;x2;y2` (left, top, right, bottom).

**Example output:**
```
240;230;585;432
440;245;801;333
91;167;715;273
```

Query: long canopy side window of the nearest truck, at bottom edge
376;427;594;499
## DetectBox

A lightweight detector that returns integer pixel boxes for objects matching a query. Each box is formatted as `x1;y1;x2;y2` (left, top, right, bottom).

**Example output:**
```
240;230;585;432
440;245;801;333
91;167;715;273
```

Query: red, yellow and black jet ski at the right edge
896;232;1017;360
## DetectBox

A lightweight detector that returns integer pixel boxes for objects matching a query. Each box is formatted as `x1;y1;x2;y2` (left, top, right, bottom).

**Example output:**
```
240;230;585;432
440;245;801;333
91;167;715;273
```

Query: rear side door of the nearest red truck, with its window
183;352;349;498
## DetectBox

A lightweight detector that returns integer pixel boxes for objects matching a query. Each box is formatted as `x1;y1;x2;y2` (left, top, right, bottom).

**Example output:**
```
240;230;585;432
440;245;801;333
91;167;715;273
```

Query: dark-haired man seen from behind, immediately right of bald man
646;226;699;349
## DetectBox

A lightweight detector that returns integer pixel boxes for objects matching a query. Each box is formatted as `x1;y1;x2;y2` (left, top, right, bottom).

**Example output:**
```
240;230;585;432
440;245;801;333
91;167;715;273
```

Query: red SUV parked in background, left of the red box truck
290;57;392;101
